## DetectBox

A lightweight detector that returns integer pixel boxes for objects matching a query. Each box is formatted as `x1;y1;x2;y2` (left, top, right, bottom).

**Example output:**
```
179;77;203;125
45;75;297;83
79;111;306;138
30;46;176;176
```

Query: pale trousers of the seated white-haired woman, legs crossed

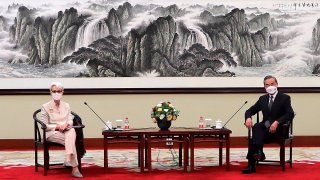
47;128;78;167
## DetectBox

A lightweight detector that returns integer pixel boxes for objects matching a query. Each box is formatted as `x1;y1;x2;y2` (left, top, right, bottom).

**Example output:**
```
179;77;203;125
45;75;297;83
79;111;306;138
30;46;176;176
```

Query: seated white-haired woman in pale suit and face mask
41;82;83;178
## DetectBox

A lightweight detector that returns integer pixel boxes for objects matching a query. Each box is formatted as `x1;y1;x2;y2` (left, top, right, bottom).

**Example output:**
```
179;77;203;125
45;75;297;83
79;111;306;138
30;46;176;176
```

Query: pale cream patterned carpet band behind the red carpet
0;147;320;171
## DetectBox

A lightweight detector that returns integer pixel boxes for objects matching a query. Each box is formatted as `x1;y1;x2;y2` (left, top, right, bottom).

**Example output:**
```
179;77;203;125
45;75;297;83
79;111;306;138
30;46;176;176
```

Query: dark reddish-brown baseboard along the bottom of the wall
0;136;320;150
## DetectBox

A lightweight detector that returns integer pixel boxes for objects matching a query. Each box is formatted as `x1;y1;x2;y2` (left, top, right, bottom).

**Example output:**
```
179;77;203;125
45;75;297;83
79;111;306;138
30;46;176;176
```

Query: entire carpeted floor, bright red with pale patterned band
0;148;320;180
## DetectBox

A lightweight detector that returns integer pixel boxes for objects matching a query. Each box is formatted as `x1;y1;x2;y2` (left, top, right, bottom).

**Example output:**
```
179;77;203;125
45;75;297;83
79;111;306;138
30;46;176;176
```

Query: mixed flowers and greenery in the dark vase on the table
151;102;179;123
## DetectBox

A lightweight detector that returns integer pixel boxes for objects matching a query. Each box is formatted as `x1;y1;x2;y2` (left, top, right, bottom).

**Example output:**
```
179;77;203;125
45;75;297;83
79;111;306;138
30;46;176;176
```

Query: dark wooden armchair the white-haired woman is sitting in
33;109;85;176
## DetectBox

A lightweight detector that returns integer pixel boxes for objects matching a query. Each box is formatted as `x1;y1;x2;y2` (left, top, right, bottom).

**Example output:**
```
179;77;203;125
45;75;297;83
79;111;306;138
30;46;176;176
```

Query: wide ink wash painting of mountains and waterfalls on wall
0;0;320;78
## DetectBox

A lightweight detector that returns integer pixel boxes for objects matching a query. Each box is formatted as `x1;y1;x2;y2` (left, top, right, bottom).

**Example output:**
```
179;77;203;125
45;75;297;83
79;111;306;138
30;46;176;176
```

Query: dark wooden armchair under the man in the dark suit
248;113;293;171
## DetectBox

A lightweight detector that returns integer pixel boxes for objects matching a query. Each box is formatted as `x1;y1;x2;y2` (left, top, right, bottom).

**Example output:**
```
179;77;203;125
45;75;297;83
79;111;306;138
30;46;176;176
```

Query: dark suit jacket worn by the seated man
245;92;294;125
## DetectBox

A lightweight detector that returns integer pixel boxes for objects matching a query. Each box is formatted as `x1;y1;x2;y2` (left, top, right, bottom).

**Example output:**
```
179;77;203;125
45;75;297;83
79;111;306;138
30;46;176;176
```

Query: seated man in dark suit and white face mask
242;75;294;174
